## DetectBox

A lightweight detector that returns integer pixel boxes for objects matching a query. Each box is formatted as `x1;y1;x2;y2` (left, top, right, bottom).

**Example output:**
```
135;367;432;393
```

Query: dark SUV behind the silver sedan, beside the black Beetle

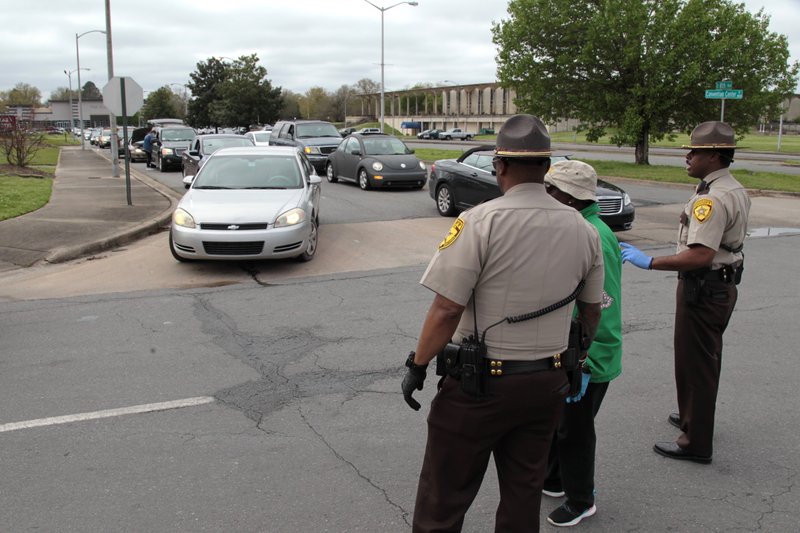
269;120;342;175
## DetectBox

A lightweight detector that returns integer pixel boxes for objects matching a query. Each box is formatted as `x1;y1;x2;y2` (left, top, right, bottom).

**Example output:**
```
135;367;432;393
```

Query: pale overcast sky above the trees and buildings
0;0;800;100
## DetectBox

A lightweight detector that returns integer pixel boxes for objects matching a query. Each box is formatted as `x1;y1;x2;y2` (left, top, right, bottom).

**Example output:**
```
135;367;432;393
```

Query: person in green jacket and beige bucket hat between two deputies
543;160;622;526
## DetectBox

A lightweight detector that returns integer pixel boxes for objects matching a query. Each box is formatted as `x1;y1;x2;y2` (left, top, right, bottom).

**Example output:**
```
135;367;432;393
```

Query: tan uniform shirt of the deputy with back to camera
420;183;603;360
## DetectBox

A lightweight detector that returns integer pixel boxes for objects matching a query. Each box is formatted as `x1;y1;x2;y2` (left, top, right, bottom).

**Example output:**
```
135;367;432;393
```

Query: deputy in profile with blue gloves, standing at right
621;121;750;464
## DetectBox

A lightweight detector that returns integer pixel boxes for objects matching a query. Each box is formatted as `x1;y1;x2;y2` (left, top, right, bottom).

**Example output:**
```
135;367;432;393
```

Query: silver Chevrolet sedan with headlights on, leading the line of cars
169;146;321;261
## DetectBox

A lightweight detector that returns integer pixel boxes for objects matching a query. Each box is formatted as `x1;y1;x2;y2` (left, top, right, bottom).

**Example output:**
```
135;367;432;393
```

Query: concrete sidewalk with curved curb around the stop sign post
0;146;177;272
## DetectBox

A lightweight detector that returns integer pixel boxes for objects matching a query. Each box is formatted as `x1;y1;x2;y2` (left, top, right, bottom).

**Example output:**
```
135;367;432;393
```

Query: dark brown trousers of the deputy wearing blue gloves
674;280;738;457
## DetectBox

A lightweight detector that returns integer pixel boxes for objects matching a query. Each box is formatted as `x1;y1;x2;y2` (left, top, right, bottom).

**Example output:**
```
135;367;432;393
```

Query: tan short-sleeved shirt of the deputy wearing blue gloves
677;168;750;270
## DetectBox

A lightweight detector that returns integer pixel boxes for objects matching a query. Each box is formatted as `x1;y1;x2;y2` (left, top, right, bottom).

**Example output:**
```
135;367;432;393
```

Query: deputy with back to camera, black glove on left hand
402;115;603;532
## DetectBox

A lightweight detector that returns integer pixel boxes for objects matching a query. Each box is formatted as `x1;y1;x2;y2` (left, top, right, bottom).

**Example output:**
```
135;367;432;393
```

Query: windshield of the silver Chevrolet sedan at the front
192;154;303;189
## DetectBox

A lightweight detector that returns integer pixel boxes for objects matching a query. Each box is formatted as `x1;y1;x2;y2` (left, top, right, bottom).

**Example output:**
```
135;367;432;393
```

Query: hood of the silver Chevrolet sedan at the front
178;188;305;224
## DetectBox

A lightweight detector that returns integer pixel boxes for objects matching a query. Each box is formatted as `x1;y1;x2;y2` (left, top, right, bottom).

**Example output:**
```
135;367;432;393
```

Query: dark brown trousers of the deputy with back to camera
413;370;569;533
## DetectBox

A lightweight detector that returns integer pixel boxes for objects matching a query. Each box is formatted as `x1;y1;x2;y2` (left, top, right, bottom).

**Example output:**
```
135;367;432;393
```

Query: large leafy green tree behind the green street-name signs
492;0;800;164
